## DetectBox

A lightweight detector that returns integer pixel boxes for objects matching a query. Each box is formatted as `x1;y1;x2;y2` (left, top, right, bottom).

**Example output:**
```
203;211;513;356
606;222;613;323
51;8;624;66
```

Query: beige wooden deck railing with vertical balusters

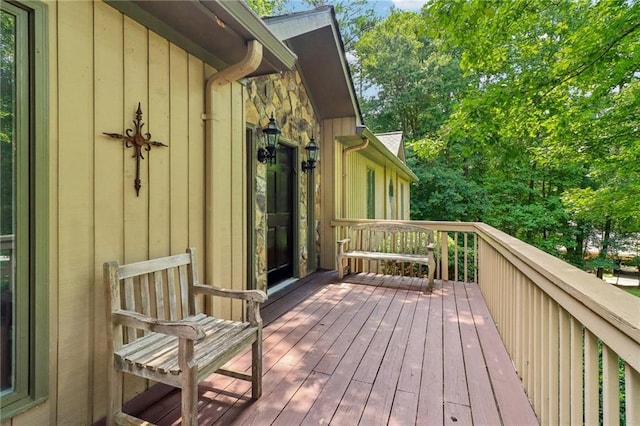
332;220;640;425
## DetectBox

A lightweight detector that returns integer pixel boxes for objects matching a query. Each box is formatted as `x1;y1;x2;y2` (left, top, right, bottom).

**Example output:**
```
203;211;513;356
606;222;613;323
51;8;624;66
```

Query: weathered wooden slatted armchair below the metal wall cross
104;248;267;426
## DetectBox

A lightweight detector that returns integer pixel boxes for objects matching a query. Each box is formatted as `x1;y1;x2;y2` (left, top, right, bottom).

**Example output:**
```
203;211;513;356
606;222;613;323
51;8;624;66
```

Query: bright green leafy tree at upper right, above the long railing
423;0;640;260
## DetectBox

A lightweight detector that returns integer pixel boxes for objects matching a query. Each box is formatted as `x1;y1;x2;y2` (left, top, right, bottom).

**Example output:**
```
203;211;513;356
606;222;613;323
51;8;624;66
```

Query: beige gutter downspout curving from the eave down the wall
202;40;262;306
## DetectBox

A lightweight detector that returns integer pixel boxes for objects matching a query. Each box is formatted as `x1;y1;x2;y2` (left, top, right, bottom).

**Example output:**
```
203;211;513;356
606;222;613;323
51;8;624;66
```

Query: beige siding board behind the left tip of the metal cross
91;2;124;421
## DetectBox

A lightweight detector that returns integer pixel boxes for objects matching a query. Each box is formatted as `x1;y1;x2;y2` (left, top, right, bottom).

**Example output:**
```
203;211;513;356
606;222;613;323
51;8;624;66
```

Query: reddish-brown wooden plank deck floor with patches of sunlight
119;271;538;426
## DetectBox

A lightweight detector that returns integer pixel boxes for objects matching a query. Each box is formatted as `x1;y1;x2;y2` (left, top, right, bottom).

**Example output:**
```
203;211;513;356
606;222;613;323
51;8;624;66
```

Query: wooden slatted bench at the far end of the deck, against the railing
336;222;436;289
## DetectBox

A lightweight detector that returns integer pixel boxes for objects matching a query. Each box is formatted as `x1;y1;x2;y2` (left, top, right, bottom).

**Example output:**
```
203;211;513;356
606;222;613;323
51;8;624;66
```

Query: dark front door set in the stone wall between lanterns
267;145;295;286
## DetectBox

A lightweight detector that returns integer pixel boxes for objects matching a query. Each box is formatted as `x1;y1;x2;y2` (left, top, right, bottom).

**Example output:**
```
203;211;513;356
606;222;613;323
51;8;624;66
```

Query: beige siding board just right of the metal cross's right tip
169;44;189;254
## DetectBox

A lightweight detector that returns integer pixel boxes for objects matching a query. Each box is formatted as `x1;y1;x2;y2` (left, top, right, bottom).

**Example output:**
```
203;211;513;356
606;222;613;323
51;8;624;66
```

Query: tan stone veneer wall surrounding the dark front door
246;70;322;289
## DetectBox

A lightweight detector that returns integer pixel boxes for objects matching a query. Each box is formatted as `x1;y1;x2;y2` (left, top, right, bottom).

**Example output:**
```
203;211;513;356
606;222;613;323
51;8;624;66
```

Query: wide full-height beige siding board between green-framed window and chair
57;2;95;424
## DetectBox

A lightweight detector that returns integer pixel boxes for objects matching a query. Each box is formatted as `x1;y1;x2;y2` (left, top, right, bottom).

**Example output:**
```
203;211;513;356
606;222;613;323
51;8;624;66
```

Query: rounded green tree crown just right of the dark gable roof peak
355;10;465;140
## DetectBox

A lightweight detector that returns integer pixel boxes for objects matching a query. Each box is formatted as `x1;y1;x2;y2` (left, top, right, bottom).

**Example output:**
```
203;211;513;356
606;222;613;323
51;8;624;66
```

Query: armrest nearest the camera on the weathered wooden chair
111;310;205;340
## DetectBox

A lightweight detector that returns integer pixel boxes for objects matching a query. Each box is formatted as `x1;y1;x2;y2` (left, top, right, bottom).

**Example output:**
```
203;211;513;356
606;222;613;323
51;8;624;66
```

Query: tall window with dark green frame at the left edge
0;1;48;420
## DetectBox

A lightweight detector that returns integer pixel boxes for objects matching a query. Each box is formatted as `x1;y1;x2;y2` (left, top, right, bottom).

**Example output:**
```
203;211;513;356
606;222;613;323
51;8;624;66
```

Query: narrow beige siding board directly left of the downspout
188;55;207;311
